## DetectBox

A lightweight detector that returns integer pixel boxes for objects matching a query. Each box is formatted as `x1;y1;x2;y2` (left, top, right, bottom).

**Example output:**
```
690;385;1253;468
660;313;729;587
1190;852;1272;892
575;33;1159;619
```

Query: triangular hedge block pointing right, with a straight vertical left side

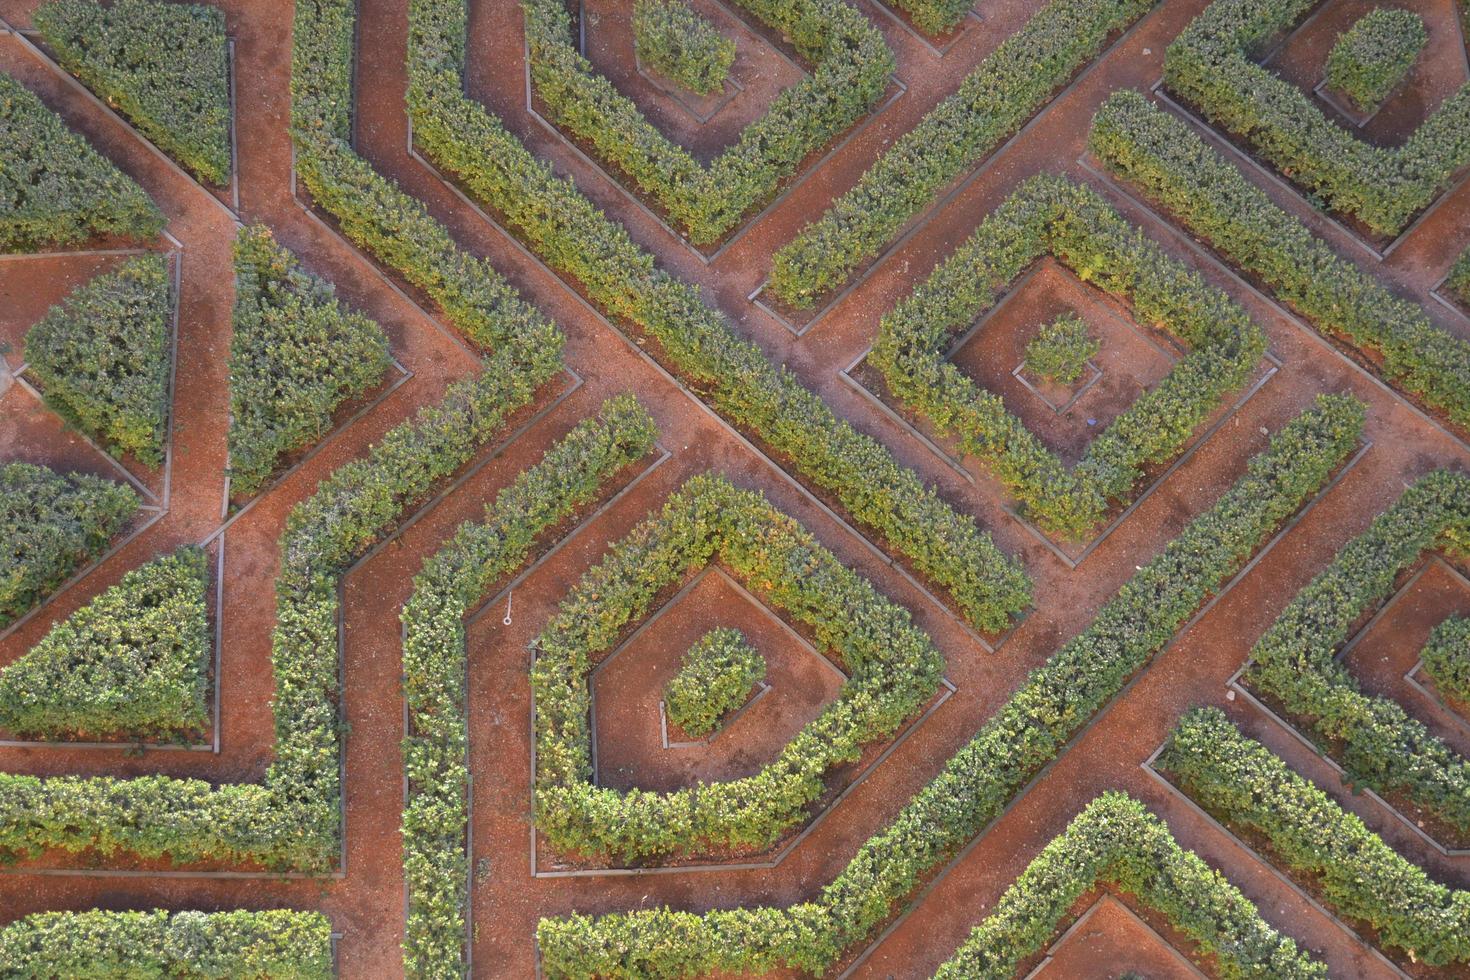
229;225;391;497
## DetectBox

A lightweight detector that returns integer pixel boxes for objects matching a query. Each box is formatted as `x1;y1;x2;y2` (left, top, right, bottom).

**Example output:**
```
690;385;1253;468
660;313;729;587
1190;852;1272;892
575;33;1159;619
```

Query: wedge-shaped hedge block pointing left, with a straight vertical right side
25;254;173;466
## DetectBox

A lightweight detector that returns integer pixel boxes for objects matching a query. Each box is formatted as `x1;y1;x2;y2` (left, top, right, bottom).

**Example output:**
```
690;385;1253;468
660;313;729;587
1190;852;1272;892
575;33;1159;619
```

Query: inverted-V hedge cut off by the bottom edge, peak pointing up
933;793;1327;980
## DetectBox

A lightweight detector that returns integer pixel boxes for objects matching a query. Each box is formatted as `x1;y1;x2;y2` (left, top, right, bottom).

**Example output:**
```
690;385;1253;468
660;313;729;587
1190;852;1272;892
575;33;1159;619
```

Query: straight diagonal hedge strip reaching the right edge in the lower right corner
1158;708;1470;965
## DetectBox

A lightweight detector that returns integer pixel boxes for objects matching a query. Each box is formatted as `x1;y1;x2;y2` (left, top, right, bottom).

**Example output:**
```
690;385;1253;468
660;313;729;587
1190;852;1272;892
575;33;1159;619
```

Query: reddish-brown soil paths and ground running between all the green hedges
0;0;1470;979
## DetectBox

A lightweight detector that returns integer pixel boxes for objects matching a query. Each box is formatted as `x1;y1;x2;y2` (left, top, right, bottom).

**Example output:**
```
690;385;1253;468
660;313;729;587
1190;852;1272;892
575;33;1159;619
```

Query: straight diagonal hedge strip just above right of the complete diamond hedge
1089;91;1470;426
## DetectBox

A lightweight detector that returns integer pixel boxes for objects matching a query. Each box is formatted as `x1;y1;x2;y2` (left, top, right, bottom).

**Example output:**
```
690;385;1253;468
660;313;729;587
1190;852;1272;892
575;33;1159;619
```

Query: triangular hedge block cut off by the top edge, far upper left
35;0;229;185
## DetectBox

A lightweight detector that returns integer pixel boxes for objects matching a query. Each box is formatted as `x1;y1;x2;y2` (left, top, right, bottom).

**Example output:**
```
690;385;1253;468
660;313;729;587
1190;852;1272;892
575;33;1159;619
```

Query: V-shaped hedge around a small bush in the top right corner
1164;0;1470;235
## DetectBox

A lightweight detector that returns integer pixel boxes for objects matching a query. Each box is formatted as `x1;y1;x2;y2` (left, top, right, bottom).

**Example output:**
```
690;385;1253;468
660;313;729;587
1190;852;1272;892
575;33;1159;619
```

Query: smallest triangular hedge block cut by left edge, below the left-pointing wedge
0;463;141;627
